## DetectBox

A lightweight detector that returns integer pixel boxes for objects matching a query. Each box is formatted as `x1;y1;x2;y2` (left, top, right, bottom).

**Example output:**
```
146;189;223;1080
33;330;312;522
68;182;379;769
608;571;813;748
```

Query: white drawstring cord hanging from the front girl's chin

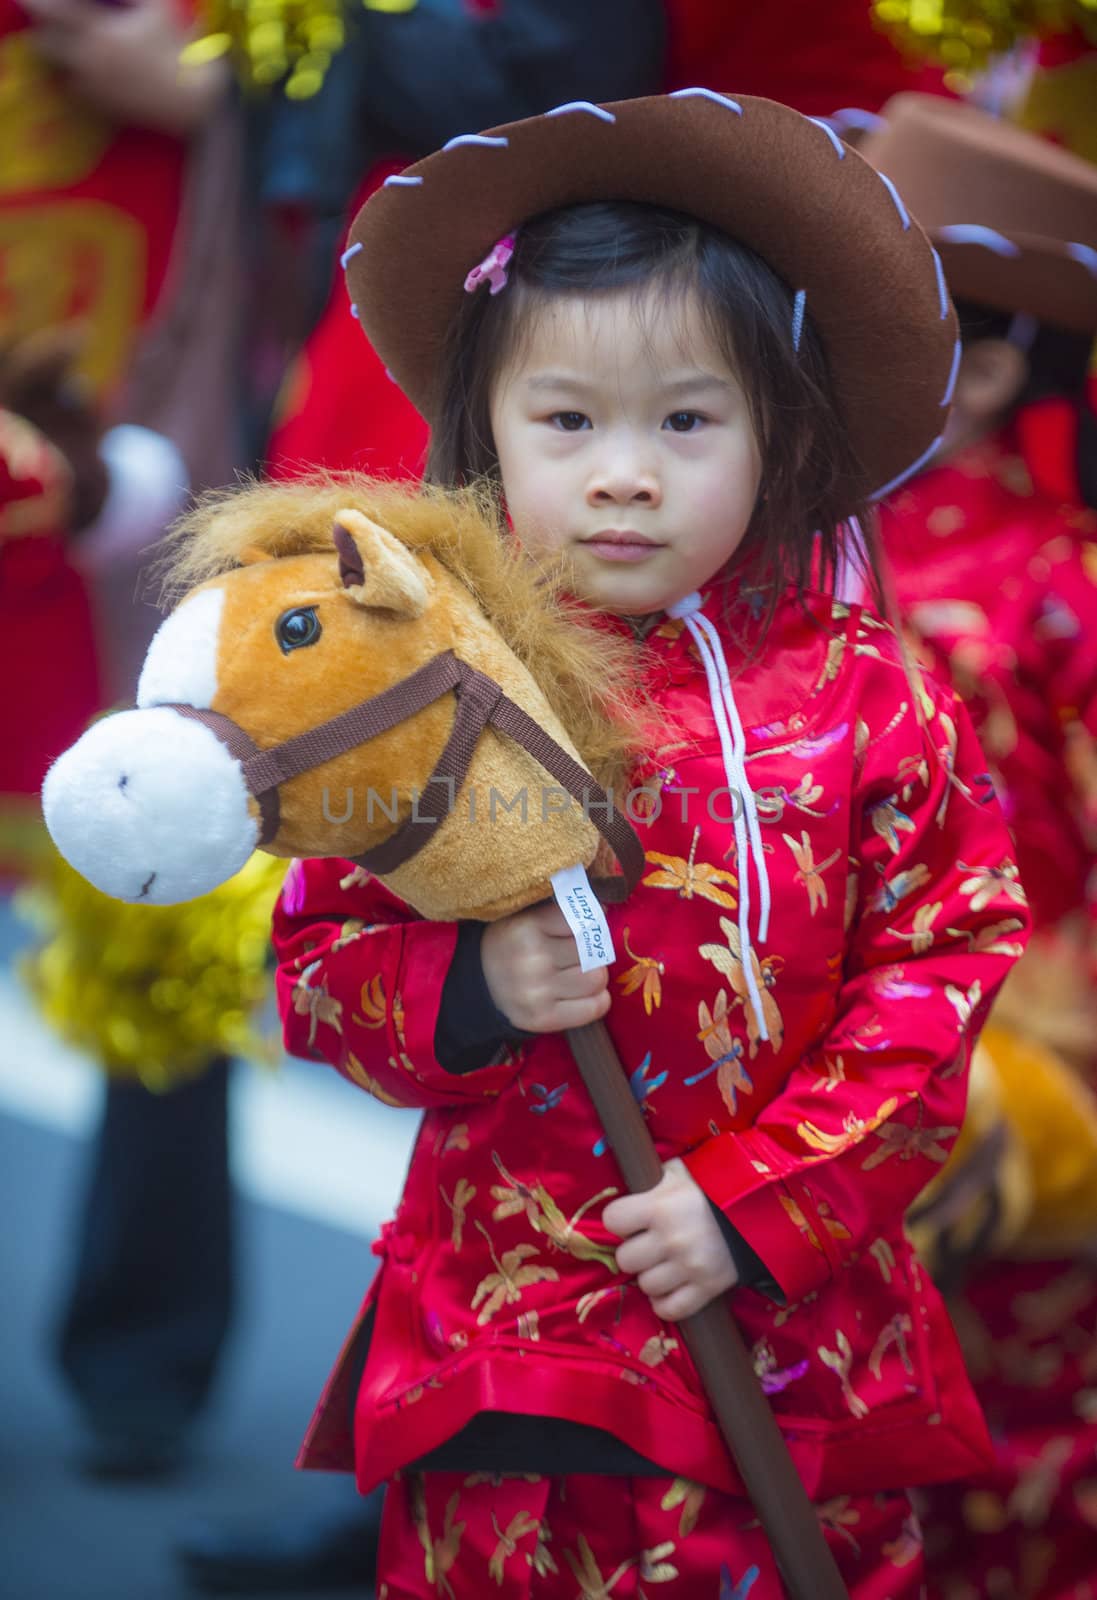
667;592;771;1040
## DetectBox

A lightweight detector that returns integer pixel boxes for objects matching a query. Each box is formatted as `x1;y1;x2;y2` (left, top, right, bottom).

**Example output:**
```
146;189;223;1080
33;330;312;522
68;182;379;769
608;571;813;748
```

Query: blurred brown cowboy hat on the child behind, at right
857;94;1097;333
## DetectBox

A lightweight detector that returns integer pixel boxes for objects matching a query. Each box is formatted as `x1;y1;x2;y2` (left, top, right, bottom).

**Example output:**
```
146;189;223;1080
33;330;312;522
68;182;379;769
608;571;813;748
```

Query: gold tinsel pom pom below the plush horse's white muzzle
19;853;286;1090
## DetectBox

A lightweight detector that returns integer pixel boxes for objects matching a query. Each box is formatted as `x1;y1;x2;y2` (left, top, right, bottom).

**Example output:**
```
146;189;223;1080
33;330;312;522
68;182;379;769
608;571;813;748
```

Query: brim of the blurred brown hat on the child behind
931;234;1097;334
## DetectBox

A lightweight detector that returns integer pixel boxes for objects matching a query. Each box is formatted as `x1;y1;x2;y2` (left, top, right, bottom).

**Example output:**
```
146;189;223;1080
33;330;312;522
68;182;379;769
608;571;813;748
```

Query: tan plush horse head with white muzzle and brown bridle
43;474;638;920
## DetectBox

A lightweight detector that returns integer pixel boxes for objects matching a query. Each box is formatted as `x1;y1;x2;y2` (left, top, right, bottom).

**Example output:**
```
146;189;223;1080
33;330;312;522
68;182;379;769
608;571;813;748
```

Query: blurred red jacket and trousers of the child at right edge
883;432;1097;1600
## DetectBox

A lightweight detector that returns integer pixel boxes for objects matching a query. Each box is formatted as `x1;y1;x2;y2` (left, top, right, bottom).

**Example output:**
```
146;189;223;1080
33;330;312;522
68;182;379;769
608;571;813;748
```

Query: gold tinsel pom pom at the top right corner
872;0;1097;90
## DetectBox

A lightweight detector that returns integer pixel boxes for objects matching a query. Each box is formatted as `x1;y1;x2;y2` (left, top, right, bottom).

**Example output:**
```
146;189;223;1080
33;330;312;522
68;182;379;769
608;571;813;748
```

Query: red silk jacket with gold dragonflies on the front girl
275;594;1027;1498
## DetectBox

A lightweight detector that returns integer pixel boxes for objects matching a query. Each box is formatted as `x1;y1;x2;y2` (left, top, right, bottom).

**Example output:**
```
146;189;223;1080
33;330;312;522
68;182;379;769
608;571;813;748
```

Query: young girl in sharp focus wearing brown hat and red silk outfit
275;91;1027;1600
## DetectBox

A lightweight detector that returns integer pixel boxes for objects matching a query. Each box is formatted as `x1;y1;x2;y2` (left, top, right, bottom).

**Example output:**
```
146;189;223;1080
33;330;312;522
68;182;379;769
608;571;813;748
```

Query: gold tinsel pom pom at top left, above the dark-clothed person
182;0;416;99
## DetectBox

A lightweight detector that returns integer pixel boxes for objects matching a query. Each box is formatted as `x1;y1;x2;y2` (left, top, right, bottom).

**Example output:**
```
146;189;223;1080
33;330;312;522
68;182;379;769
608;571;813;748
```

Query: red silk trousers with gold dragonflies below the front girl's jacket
377;1472;924;1600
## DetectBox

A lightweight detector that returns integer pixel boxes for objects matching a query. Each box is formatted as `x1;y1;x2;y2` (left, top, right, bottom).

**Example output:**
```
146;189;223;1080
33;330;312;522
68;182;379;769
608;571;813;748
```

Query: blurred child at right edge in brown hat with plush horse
862;96;1097;1600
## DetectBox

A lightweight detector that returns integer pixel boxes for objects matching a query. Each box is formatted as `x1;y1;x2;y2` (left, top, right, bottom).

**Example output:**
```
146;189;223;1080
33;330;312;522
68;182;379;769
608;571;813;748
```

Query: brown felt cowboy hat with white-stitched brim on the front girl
344;90;958;491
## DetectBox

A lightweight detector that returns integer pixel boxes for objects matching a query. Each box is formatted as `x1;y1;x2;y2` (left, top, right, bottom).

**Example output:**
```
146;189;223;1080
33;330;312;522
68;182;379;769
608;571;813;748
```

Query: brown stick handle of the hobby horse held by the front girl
568;1022;849;1600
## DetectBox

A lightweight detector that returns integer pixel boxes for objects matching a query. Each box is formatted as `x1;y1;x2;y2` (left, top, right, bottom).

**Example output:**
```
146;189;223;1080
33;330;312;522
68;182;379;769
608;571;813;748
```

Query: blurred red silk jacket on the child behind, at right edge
881;432;1097;926
